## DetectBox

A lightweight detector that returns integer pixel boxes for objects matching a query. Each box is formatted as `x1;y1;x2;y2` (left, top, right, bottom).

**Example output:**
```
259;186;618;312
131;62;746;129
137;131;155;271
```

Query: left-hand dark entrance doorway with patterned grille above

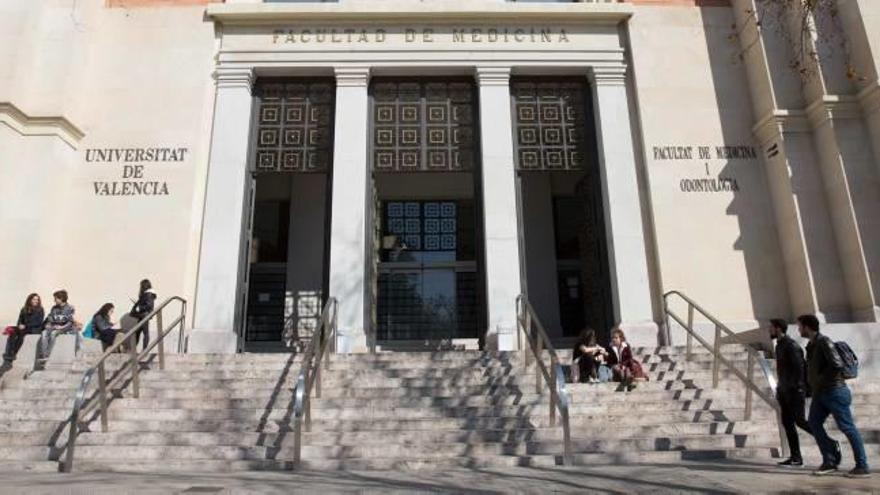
239;79;334;352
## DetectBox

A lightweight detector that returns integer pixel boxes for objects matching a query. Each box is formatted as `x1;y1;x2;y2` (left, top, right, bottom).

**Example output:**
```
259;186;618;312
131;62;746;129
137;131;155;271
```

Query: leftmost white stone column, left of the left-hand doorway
189;69;253;353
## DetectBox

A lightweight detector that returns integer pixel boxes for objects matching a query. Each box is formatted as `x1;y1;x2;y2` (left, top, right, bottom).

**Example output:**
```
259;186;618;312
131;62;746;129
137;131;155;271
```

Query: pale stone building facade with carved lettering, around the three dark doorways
0;0;880;360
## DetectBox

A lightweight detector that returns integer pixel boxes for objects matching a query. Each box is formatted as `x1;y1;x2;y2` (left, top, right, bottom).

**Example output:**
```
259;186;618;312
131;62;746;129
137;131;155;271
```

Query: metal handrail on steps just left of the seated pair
516;294;574;466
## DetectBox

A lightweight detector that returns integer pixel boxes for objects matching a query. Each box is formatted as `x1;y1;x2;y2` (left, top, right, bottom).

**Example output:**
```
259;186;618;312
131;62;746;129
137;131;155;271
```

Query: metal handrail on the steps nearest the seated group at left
62;296;186;473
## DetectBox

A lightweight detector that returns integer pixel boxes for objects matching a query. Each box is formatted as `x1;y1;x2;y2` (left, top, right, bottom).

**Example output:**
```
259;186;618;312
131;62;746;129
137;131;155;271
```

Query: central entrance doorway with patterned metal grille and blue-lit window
370;78;486;349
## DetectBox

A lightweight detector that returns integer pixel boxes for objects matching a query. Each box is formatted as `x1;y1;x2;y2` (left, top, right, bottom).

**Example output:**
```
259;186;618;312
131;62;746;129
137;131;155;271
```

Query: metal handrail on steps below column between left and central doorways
293;297;338;469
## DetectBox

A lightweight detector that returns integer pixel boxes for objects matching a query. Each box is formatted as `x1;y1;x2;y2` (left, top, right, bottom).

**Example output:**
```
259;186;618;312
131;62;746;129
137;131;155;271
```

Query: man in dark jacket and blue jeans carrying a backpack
797;315;870;478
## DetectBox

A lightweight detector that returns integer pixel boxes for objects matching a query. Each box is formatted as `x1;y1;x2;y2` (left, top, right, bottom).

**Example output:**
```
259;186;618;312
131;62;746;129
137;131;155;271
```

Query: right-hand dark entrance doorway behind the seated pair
511;78;614;342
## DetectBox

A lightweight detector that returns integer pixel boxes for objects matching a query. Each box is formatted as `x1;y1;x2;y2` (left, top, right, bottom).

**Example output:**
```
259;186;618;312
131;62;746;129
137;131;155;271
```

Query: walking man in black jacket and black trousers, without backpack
770;319;816;467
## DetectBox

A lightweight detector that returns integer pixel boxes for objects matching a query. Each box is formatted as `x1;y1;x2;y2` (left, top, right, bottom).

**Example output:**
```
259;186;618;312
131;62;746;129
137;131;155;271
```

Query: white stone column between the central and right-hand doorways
476;67;522;350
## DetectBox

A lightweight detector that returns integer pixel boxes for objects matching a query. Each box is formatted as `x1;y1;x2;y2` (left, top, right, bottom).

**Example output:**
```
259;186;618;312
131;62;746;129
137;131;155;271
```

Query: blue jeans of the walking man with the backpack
807;385;868;469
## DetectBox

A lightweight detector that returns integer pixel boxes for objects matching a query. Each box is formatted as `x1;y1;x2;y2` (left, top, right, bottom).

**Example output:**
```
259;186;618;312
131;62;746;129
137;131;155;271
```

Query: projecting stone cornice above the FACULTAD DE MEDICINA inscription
206;0;634;24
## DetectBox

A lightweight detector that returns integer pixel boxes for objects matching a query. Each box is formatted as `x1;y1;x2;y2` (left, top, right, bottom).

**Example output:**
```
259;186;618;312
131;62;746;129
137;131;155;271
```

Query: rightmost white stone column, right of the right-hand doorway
590;67;658;345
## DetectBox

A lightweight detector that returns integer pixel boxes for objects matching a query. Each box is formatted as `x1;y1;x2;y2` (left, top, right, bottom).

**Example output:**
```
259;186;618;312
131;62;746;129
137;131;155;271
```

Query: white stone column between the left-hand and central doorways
330;67;370;352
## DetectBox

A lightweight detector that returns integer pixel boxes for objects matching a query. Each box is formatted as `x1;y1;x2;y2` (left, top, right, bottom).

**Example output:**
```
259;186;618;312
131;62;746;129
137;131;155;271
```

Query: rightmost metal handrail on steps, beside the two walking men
663;290;788;456
